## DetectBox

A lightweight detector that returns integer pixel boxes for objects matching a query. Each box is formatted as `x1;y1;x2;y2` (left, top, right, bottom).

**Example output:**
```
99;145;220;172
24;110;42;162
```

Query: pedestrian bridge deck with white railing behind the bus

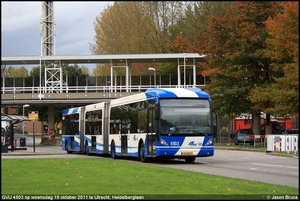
1;85;203;106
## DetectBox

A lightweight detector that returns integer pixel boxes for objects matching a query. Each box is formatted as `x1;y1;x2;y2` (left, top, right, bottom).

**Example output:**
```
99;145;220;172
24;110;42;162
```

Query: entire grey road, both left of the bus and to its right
1;136;299;188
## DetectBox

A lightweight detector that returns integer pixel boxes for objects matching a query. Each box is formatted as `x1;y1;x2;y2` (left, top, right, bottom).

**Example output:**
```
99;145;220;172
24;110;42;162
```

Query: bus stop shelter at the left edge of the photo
1;115;31;153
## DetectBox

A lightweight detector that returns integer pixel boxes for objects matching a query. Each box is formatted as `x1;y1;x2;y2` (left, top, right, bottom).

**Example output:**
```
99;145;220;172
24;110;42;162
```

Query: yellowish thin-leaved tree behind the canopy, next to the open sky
91;1;186;75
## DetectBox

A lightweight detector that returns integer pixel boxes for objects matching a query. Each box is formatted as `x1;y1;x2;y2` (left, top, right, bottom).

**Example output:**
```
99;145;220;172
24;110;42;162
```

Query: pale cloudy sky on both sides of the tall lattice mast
1;1;113;56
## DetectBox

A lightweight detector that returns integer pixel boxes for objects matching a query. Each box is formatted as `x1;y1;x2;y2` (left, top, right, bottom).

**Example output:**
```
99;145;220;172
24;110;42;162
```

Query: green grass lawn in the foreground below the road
1;158;299;200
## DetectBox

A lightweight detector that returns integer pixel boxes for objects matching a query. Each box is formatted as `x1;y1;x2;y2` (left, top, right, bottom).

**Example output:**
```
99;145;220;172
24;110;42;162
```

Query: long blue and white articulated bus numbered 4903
62;88;214;163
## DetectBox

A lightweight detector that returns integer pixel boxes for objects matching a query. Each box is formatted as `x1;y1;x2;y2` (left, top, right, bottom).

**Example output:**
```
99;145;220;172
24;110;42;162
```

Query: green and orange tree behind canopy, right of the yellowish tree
164;1;233;76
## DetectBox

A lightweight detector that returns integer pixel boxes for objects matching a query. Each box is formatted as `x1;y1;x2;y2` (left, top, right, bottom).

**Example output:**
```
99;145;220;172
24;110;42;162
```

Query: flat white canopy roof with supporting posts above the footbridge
1;53;205;100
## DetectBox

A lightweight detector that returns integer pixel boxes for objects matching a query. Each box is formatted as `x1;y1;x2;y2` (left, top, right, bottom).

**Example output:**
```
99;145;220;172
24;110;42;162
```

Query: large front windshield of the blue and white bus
160;99;212;136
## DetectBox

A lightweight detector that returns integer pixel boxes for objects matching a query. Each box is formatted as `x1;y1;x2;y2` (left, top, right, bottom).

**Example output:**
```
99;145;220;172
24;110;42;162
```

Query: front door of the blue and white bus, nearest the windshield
148;108;157;156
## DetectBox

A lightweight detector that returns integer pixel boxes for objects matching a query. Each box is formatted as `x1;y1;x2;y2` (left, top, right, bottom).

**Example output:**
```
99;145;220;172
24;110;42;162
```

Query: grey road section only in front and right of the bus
148;149;299;188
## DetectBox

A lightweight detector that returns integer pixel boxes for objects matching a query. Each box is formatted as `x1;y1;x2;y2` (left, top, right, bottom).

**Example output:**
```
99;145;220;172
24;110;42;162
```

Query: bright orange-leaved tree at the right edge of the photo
250;2;299;116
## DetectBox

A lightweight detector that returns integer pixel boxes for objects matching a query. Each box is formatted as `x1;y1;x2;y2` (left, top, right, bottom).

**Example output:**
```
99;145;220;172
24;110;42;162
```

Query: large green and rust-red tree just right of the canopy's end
199;2;281;121
